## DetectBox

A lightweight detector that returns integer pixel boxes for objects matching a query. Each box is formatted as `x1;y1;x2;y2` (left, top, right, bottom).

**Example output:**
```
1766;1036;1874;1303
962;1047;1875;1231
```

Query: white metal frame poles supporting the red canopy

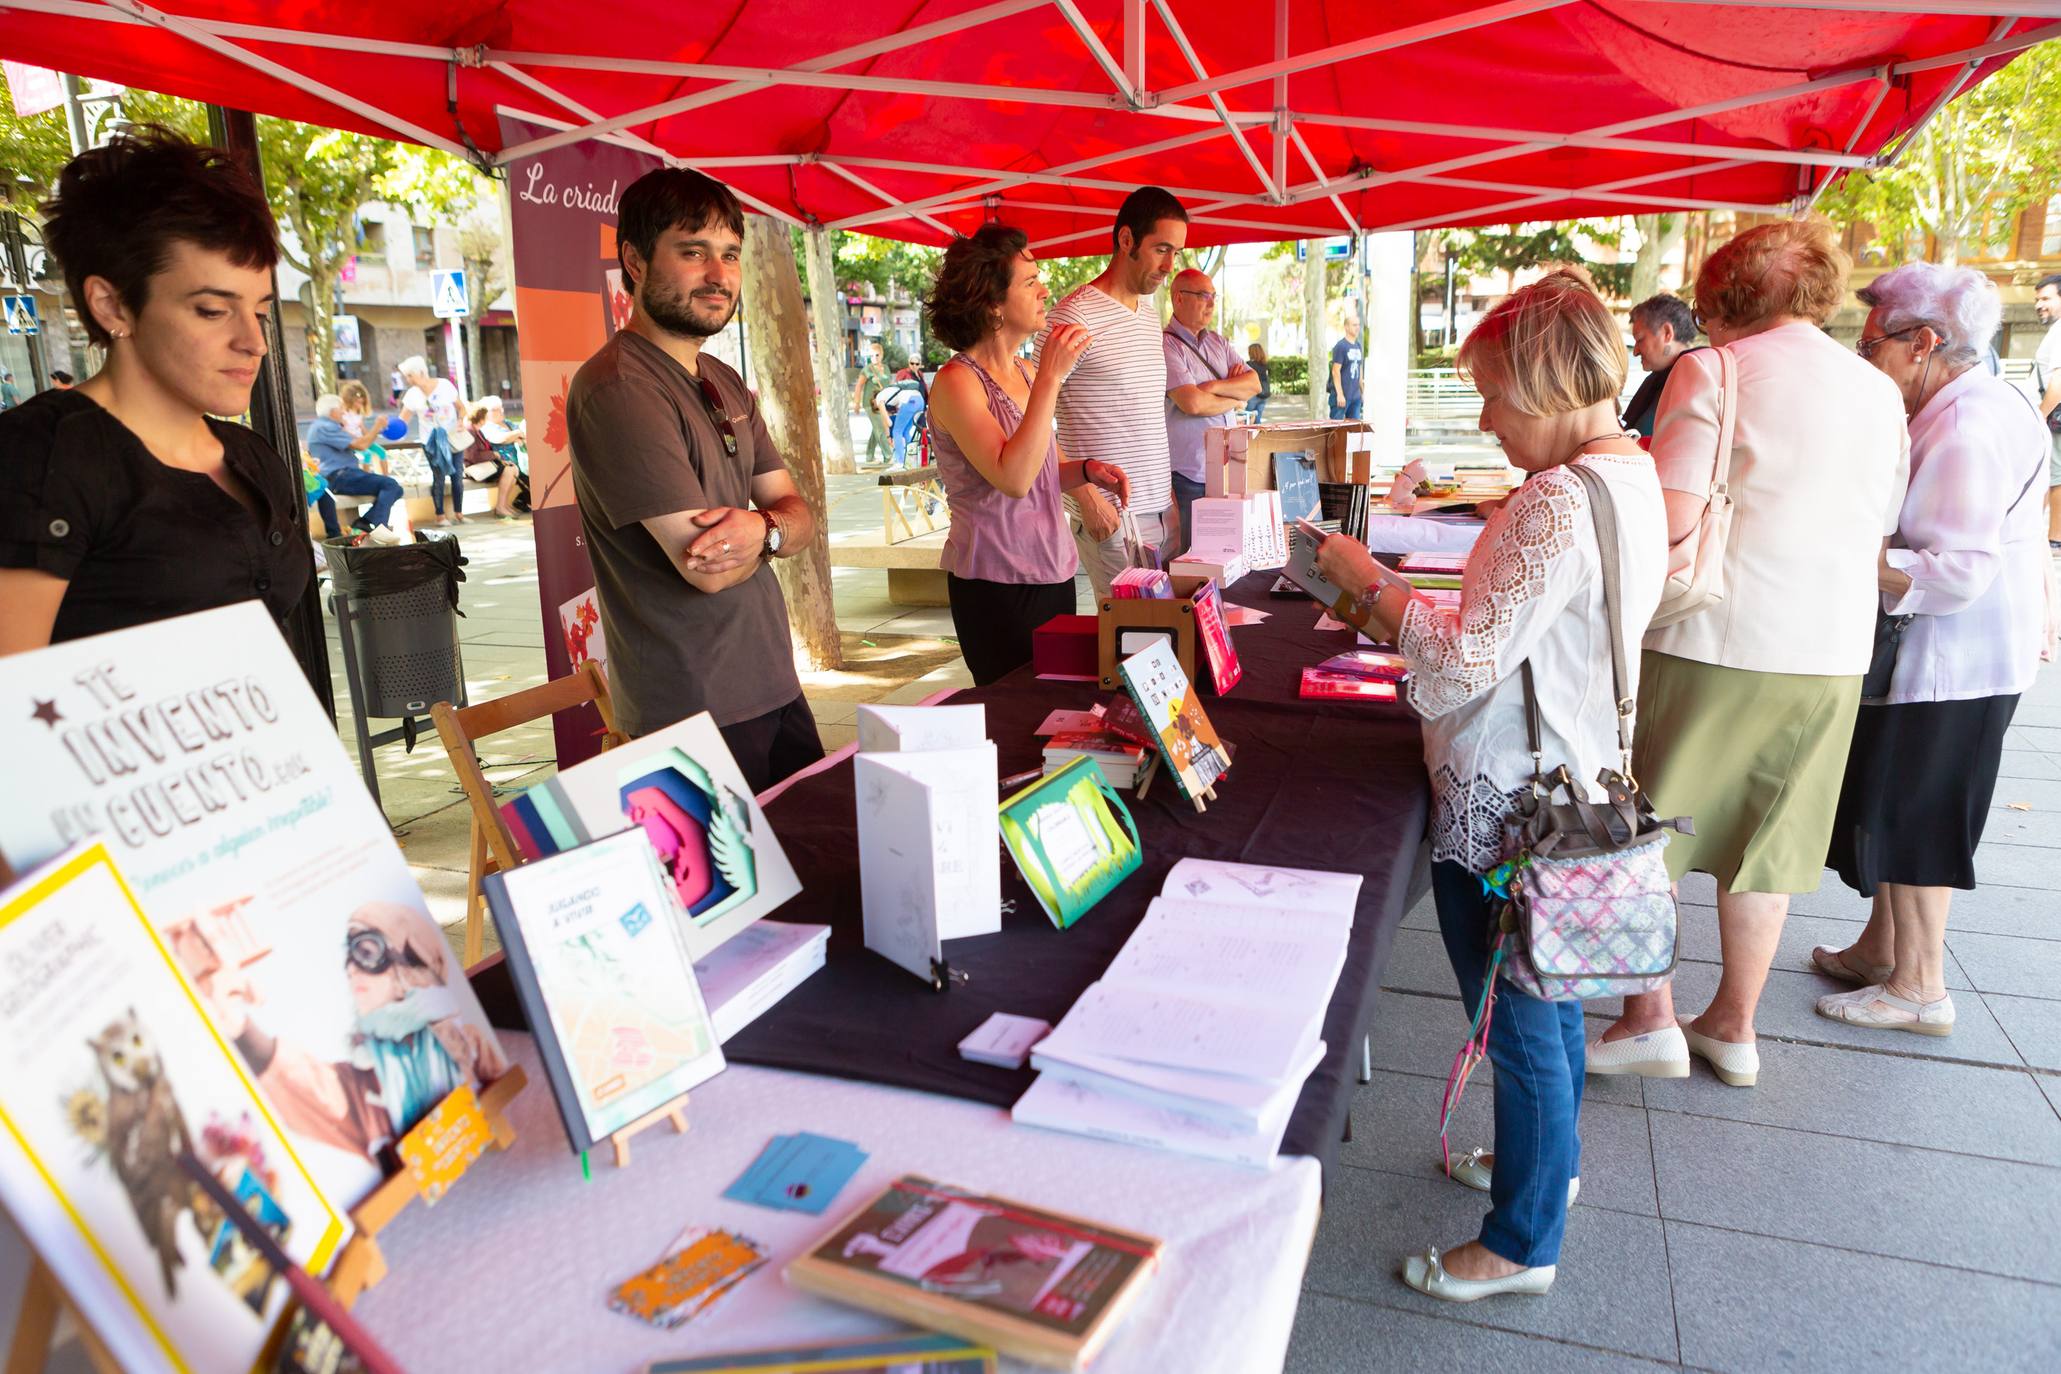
16;0;2061;251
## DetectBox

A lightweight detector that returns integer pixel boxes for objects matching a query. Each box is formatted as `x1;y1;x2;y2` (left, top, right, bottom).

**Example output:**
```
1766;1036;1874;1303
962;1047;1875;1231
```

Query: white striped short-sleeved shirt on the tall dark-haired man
1037;284;1173;515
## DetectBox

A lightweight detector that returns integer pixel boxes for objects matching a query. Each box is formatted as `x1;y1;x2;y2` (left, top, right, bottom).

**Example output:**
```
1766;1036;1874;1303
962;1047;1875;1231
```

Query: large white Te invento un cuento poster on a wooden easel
0;602;507;1205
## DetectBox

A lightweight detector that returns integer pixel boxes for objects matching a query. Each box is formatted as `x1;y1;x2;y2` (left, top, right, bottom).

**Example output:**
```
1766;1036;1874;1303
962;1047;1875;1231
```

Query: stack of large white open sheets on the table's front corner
1012;859;1360;1168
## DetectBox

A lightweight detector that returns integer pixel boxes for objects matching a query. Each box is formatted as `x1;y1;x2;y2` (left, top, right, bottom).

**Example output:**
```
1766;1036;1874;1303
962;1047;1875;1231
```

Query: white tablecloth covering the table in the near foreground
357;1032;1319;1374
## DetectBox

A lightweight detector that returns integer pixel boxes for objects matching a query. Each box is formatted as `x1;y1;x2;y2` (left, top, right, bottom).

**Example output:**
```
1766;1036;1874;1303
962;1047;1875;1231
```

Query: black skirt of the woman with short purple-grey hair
1826;696;2018;896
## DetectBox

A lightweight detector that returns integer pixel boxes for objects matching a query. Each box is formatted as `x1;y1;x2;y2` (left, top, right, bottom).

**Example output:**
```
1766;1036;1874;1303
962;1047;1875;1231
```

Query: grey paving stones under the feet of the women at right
1288;605;2061;1374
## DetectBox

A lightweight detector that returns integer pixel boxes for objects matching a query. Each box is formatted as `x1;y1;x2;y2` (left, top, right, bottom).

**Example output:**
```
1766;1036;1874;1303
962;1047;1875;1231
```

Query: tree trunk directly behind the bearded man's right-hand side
744;214;843;669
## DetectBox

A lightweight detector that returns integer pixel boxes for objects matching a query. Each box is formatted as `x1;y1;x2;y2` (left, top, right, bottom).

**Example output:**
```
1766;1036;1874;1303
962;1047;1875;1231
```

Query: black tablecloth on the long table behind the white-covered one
723;573;1428;1164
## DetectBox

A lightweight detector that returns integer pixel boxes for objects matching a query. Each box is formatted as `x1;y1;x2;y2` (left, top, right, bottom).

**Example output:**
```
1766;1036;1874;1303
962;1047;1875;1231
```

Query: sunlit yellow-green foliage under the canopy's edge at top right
1818;43;2061;264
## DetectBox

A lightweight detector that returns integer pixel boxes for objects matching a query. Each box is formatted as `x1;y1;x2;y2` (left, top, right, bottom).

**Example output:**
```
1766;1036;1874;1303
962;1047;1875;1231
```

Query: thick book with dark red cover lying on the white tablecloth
785;1174;1162;1370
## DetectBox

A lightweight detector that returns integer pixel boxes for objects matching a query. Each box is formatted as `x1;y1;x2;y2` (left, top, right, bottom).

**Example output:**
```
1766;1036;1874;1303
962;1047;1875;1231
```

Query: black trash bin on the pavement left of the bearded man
324;538;466;721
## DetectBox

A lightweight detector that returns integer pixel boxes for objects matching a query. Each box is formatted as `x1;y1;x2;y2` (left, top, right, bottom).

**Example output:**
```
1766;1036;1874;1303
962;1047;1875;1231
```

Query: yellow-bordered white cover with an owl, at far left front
0;845;348;1370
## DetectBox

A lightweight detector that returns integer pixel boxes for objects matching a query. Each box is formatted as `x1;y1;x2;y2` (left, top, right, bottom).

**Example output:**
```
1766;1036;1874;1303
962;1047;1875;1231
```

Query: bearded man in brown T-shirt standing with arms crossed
565;167;822;793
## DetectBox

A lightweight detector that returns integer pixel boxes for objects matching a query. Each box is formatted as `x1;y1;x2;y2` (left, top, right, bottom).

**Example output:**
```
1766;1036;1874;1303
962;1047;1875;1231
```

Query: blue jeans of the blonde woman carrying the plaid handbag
1430;863;1585;1267
